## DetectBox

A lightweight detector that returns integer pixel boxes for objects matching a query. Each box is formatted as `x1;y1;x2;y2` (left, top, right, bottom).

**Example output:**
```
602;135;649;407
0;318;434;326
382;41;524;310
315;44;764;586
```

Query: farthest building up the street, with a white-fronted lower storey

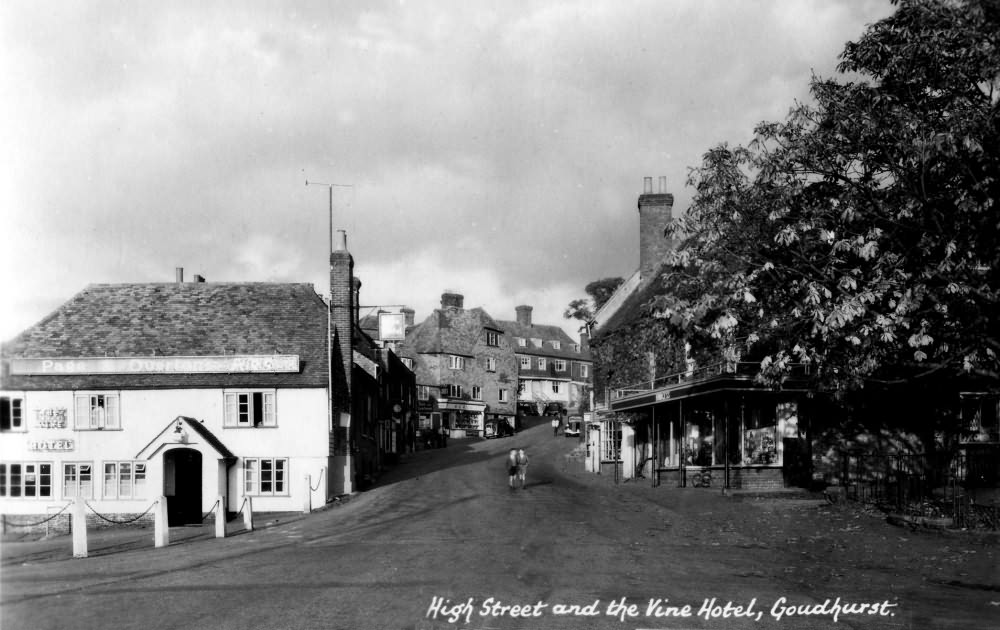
498;305;593;415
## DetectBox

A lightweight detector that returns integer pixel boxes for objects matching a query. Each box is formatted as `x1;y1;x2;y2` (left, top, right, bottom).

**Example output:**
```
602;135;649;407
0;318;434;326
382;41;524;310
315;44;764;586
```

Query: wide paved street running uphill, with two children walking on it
0;425;1000;630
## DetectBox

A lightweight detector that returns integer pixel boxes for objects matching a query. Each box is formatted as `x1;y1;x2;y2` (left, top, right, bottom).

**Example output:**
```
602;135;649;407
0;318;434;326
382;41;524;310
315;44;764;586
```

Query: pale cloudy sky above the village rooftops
0;0;893;340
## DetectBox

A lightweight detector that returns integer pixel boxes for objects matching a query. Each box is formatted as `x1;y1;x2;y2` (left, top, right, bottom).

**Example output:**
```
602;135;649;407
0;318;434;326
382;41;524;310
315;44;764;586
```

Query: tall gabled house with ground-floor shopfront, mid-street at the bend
398;292;517;437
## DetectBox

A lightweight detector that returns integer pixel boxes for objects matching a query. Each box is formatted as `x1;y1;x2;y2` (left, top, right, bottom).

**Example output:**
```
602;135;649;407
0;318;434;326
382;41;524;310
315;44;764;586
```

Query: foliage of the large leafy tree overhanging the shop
655;0;1000;388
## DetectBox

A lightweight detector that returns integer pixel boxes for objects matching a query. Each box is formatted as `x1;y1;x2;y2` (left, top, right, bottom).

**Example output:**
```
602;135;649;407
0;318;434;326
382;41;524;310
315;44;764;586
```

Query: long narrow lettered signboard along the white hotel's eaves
10;354;299;375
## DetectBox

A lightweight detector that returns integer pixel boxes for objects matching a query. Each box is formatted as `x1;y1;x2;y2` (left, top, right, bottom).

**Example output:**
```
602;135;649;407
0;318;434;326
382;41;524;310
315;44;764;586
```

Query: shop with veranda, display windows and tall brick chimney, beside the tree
587;178;820;489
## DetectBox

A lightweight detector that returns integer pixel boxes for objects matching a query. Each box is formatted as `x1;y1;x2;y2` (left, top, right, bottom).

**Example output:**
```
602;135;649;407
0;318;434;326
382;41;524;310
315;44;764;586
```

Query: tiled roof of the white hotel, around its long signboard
0;282;327;389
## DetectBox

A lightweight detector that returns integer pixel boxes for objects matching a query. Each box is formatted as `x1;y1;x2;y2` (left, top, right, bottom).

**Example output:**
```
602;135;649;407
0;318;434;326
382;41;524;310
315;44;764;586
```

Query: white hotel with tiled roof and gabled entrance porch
0;282;338;527
